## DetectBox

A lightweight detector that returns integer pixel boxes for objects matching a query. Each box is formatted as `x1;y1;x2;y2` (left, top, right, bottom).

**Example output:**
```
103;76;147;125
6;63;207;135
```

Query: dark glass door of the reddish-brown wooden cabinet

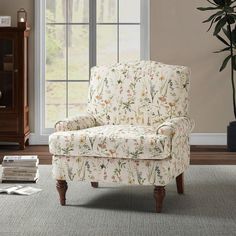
0;38;14;109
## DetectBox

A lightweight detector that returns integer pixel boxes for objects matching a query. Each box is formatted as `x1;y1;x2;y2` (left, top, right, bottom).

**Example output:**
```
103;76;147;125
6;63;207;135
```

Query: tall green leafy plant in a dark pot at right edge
197;0;236;152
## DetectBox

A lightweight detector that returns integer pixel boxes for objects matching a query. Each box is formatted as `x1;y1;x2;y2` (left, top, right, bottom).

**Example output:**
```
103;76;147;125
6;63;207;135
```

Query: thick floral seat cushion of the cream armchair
49;125;171;160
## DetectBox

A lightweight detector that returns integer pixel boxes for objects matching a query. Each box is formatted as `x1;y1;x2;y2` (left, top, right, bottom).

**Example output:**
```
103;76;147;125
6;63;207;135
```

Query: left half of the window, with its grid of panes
44;0;90;128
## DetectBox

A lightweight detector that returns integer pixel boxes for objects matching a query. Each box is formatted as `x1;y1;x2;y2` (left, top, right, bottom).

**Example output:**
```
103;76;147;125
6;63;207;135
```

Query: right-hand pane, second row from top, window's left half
68;25;89;80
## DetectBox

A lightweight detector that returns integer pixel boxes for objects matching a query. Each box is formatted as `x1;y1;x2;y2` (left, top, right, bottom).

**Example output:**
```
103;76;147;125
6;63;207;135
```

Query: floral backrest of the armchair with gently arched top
88;61;190;126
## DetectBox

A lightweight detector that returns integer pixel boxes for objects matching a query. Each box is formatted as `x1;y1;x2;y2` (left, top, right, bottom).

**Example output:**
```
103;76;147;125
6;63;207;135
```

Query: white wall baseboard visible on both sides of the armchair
30;133;227;145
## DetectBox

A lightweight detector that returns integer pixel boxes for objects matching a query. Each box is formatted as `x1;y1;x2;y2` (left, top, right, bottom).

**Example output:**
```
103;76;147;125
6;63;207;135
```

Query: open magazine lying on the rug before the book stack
0;185;42;195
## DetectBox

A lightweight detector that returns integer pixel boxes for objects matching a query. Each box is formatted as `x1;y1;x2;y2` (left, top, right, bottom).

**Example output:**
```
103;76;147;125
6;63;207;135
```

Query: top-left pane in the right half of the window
97;0;117;23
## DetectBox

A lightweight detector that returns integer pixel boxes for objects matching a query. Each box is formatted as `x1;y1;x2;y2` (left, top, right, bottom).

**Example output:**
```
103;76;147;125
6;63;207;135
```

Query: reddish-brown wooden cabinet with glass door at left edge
0;24;30;149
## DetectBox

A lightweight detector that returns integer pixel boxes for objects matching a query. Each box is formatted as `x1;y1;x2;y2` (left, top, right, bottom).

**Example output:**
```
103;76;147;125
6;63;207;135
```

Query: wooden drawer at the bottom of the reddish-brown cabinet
0;114;18;133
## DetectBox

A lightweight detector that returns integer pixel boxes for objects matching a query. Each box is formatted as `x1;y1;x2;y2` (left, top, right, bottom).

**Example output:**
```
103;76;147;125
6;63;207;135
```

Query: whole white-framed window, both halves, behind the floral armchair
36;0;149;139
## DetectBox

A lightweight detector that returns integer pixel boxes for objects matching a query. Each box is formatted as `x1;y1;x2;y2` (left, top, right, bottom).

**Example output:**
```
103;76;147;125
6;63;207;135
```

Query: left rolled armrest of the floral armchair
55;113;96;132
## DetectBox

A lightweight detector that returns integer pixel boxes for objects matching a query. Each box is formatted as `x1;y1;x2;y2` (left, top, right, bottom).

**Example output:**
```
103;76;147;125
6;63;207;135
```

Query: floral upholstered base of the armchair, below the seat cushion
53;156;189;186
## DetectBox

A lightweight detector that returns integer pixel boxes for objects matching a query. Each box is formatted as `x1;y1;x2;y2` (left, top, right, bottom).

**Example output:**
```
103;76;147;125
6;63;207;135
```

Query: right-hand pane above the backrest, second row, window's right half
119;25;140;61
